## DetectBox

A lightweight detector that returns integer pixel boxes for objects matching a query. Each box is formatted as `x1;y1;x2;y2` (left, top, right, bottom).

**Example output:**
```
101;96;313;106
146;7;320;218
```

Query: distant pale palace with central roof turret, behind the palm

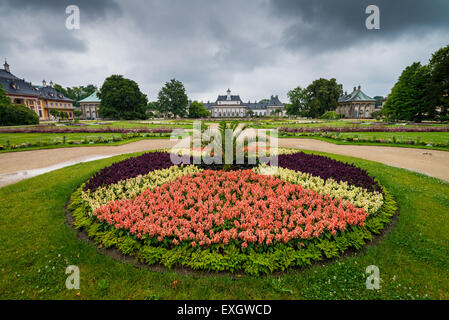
204;89;285;118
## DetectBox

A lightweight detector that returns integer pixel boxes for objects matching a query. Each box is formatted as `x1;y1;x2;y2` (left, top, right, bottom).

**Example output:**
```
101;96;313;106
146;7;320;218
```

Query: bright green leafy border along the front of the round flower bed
67;178;398;275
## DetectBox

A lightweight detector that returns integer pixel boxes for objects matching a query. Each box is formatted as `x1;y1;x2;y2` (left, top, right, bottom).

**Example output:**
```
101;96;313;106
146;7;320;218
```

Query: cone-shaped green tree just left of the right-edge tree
382;62;435;122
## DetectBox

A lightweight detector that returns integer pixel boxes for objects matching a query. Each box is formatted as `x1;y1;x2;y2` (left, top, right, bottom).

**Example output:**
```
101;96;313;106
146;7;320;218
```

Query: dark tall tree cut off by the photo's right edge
429;45;449;116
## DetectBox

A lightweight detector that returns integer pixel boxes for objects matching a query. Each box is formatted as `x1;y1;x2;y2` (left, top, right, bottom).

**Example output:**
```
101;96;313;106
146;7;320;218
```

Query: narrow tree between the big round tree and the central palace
158;79;188;117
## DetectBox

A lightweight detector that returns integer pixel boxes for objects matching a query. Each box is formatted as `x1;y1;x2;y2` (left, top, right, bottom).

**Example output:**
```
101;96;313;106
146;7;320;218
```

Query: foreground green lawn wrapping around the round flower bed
0;150;449;299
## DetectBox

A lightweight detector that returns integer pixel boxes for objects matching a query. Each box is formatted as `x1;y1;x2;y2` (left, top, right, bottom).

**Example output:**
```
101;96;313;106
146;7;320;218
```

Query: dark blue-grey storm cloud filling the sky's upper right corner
270;0;449;51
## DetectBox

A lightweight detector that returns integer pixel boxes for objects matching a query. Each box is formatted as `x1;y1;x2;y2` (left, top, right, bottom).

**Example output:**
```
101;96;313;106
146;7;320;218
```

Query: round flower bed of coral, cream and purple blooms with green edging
70;150;396;274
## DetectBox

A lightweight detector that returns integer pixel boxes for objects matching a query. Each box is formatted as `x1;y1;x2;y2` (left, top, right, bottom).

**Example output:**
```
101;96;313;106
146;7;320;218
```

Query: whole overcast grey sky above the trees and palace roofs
0;0;449;102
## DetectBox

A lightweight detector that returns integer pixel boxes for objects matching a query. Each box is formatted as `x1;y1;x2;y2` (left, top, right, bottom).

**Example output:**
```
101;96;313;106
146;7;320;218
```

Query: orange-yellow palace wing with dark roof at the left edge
0;60;75;120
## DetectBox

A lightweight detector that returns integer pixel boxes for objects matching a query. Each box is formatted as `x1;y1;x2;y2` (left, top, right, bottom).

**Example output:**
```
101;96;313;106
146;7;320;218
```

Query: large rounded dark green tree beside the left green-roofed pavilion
98;75;148;120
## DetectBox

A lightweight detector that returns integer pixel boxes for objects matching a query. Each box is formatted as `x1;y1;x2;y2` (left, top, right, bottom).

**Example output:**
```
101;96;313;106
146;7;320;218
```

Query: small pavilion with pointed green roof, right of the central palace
335;86;378;119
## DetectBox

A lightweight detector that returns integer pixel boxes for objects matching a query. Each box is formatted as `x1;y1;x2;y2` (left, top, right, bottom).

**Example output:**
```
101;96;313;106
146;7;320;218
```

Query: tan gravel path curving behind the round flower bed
0;139;449;187
